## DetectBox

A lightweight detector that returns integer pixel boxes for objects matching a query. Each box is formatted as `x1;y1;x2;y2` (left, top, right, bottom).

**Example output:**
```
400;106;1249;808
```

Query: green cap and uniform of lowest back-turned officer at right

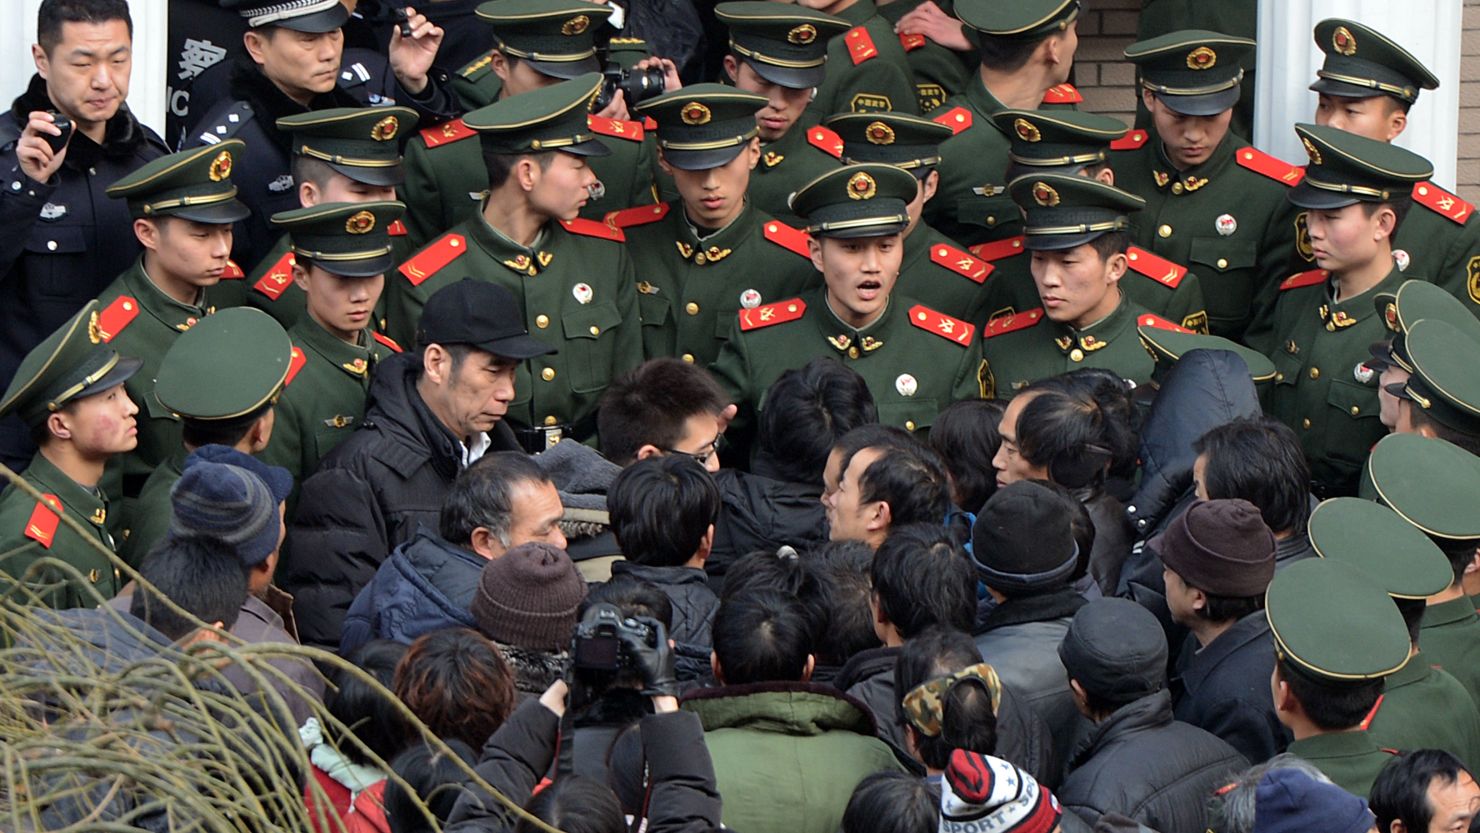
1264;558;1412;796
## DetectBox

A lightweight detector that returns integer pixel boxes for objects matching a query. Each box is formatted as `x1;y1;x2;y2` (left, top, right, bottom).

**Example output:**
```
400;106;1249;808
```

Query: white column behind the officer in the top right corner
1255;0;1462;188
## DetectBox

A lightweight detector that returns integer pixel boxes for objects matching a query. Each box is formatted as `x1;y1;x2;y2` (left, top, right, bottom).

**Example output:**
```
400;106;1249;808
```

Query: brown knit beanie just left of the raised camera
471;543;586;651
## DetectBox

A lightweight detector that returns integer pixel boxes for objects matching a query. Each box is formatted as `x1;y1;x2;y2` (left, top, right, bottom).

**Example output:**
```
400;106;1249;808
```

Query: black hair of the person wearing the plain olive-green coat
713;590;813;685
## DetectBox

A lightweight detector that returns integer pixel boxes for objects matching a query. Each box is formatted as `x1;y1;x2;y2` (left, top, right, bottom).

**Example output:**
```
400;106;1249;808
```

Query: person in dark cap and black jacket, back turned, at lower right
1058;599;1248;830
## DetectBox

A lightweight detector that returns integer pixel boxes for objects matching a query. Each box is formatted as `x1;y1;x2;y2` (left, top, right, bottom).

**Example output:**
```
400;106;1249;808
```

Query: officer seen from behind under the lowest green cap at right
1264;558;1412;796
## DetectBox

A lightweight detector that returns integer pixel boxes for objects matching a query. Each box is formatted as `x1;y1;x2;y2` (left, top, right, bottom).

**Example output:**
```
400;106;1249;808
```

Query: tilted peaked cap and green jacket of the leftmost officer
0;300;141;608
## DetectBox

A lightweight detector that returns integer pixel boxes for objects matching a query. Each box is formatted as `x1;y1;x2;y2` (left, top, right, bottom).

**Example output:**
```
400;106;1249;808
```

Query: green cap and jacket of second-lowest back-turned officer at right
1308;497;1480;766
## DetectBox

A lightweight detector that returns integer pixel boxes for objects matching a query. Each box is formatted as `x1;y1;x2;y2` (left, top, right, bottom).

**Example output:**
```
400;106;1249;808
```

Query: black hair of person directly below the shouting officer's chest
756;358;879;485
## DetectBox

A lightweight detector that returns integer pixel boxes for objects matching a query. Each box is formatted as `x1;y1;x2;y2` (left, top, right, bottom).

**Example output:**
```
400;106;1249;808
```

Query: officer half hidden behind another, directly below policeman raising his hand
244;107;416;327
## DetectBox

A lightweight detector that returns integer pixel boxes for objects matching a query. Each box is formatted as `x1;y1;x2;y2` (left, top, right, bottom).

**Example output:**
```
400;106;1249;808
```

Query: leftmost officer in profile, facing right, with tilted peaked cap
0;300;141;608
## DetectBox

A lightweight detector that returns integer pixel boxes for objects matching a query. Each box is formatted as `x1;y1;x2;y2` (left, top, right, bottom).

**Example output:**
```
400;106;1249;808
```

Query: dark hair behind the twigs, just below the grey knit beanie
129;536;247;642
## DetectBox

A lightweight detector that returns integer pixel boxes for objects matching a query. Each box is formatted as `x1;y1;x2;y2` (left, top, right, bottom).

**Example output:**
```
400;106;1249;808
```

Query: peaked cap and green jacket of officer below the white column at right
1249;124;1433;497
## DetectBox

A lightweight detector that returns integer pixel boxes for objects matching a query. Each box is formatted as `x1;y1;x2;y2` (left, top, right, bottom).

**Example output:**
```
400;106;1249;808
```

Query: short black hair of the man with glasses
596;358;728;466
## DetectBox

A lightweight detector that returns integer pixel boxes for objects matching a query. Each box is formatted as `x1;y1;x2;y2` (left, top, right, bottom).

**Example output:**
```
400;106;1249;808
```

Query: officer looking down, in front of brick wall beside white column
1110;31;1299;340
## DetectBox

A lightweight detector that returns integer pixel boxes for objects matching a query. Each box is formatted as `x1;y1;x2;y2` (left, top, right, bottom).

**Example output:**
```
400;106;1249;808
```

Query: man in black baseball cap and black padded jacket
278;278;555;650
